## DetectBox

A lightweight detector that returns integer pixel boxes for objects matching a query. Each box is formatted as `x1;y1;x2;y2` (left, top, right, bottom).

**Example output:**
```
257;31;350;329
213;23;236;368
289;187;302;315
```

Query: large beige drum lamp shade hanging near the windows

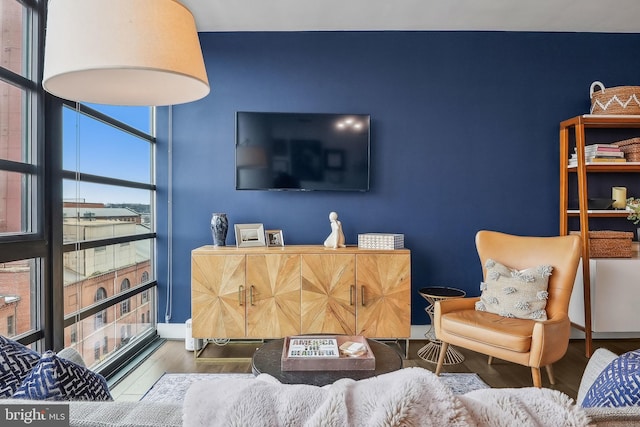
42;0;210;106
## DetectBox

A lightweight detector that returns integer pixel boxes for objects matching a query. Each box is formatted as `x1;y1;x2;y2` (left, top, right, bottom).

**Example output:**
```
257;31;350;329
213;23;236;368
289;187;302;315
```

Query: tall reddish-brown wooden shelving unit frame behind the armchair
560;115;640;357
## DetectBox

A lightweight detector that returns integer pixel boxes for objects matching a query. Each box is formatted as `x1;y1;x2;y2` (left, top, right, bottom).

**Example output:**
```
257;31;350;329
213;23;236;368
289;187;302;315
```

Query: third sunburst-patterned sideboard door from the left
301;253;356;335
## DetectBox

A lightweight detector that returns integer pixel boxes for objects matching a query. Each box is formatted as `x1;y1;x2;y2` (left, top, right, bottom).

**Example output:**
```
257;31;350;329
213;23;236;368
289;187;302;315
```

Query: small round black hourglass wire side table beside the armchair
418;286;466;365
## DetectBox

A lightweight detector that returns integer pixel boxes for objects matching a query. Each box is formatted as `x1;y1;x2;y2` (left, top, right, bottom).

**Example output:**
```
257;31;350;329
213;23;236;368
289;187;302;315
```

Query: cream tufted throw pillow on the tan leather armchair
476;259;553;320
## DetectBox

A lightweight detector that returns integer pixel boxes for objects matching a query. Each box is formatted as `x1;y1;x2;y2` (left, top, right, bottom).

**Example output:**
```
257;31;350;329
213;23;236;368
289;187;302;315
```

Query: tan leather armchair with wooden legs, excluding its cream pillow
434;230;581;387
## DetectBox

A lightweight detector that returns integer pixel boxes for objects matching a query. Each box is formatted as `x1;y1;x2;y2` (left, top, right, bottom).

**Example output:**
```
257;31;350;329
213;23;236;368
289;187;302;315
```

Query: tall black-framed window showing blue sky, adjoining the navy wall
60;103;155;370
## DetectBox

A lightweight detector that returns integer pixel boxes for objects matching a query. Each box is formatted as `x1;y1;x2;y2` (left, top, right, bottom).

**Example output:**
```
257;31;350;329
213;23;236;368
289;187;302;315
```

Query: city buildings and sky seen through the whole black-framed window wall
0;0;156;367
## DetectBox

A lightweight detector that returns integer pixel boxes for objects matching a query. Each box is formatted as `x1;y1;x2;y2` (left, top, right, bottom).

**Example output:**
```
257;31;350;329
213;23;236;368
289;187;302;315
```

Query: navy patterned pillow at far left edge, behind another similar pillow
0;335;40;399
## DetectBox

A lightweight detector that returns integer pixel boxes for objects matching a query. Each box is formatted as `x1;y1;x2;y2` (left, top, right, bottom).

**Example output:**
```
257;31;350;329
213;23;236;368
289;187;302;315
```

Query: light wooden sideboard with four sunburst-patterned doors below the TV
191;245;411;339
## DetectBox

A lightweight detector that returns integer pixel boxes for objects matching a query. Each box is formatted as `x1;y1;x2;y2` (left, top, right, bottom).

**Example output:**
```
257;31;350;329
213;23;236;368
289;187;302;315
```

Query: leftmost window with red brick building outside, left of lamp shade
0;0;41;343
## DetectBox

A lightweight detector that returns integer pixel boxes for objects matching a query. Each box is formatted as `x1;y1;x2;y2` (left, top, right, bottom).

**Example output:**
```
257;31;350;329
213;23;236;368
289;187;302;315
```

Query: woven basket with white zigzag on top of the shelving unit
589;82;640;114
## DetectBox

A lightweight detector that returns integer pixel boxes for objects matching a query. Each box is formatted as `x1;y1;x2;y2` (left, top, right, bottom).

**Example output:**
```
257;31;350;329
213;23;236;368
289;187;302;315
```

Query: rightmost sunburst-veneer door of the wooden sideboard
356;254;411;338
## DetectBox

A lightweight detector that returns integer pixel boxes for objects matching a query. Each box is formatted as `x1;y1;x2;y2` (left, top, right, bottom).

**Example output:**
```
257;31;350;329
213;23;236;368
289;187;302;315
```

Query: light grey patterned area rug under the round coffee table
140;373;490;404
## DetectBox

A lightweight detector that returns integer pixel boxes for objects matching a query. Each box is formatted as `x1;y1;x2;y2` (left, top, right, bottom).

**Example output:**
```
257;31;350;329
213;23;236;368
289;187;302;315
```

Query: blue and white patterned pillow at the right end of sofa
582;350;640;408
